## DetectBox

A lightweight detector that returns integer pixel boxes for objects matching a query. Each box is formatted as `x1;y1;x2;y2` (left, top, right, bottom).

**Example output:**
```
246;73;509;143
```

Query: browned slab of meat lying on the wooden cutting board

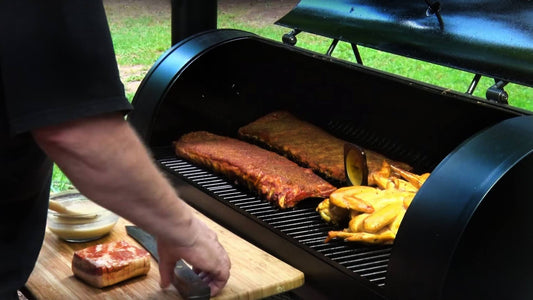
72;241;150;288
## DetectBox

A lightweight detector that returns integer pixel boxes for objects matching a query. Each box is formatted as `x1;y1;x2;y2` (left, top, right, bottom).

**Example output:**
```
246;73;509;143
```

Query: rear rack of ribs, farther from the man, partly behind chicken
239;111;412;183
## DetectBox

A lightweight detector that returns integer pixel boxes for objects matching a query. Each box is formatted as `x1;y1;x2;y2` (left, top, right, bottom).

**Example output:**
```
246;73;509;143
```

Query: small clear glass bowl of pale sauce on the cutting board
47;191;119;243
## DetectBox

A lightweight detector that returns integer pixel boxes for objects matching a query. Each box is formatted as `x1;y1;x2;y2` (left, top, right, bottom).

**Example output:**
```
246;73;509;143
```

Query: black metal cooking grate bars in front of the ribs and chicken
158;155;391;287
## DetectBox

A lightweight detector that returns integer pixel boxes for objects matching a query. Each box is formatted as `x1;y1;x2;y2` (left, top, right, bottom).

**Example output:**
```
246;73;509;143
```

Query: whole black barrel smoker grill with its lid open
128;0;533;299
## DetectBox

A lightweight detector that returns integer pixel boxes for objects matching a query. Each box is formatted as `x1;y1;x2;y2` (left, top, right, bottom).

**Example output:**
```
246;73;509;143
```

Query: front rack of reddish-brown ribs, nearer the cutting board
174;131;335;208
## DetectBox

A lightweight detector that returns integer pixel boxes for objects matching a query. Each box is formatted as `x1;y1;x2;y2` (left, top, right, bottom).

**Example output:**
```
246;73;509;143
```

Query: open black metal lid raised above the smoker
276;0;533;86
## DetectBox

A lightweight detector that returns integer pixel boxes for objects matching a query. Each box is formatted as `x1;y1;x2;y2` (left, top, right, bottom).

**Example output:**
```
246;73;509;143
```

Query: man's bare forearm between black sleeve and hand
33;114;197;243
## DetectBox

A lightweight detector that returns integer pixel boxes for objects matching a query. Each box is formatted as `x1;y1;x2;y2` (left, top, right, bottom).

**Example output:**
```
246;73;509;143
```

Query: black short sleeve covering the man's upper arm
0;0;132;134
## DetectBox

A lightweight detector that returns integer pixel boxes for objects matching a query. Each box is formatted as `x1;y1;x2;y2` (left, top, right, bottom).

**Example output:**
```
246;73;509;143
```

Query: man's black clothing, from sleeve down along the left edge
0;0;132;299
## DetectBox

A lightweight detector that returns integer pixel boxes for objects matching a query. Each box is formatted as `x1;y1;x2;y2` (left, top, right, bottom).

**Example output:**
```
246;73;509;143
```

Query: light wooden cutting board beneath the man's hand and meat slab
26;211;304;299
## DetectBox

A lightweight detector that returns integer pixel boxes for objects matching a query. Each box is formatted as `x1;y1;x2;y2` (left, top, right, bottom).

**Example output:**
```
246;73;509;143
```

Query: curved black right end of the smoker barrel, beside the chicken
388;116;533;299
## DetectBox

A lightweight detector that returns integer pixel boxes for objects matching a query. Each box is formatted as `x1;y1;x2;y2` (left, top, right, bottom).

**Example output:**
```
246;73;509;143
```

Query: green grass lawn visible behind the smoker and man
52;14;533;191
